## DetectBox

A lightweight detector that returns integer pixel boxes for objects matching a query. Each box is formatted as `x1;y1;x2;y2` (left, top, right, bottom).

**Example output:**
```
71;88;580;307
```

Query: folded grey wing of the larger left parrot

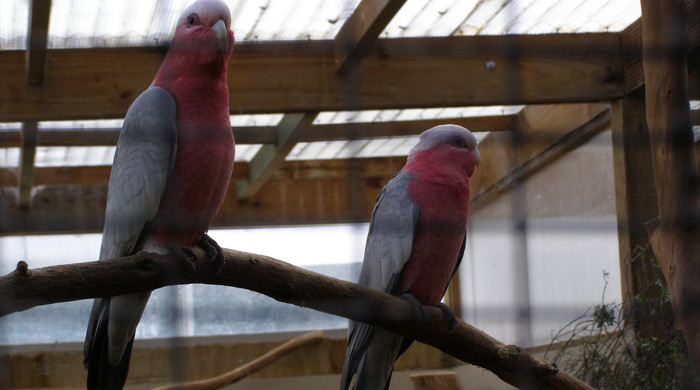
100;87;177;259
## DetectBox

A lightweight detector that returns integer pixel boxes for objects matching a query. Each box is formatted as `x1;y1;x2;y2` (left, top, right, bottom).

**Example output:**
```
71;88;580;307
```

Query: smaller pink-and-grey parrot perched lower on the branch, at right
340;125;479;390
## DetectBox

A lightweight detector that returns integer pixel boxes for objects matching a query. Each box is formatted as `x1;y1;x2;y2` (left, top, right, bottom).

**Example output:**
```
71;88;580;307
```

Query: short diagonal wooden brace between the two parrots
236;112;318;201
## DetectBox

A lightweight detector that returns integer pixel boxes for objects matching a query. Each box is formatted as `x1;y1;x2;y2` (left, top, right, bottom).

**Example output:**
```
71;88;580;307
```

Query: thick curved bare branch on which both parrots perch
0;248;592;390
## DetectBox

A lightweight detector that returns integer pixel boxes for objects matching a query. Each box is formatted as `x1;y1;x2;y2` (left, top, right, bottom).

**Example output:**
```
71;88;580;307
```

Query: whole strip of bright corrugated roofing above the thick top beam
0;0;641;50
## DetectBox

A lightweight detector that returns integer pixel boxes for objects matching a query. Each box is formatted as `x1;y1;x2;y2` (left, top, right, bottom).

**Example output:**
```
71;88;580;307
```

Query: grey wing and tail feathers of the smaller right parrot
340;171;420;389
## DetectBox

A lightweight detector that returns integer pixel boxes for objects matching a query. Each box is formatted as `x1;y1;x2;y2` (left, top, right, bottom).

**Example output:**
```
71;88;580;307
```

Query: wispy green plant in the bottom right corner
545;247;700;390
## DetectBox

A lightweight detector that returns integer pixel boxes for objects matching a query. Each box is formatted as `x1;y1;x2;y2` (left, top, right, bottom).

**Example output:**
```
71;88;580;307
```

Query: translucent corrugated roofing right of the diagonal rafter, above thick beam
382;0;641;38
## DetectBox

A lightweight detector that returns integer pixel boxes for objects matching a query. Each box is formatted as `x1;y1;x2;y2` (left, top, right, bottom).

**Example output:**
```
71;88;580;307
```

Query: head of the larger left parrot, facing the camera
170;0;234;63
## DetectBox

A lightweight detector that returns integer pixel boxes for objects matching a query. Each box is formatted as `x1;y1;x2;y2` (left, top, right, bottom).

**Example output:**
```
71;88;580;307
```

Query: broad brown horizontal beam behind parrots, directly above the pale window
0;157;406;235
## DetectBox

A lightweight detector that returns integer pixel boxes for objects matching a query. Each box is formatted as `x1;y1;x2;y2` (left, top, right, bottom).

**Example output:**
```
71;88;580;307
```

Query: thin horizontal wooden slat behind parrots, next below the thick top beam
0;115;518;148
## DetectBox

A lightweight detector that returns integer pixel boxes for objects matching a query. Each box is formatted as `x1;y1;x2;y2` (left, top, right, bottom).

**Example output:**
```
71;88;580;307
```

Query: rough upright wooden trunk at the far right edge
642;0;700;374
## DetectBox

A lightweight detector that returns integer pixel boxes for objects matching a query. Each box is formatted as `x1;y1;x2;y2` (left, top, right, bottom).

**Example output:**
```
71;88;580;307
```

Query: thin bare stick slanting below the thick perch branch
153;330;323;390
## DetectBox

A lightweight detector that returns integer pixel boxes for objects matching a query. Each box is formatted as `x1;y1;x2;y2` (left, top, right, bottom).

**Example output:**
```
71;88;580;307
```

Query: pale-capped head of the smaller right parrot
408;125;480;177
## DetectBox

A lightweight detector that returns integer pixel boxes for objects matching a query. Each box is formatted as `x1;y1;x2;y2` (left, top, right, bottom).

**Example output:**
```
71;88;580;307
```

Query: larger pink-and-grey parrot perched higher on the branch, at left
83;0;234;389
